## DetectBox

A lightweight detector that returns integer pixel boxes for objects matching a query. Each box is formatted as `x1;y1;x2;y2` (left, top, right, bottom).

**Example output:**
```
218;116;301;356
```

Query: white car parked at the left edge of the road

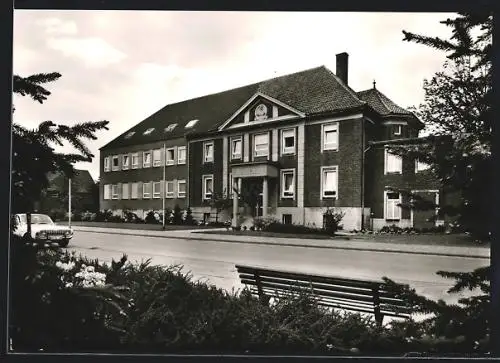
13;213;73;247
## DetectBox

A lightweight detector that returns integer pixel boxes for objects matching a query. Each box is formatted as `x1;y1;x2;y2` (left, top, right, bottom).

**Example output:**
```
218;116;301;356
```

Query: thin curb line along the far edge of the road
71;229;491;260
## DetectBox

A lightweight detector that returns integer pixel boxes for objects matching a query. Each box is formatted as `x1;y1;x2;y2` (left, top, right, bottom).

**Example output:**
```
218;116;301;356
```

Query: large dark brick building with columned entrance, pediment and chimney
100;53;446;229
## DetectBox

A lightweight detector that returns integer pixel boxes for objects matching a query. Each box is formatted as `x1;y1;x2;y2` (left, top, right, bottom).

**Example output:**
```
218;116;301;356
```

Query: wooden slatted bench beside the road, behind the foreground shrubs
236;265;411;325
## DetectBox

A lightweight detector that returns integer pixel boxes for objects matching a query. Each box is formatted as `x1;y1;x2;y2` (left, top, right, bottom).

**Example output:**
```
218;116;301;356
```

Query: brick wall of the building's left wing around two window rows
99;138;189;213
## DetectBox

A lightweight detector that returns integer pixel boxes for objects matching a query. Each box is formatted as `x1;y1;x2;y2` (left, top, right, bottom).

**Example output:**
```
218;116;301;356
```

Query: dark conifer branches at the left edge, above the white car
11;72;109;233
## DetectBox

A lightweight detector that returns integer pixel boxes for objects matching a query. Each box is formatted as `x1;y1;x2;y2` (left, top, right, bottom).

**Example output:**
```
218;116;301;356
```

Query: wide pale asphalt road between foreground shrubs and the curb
68;231;489;302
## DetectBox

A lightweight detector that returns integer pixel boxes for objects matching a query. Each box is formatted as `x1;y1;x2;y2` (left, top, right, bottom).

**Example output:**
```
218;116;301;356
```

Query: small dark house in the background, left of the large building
36;169;99;220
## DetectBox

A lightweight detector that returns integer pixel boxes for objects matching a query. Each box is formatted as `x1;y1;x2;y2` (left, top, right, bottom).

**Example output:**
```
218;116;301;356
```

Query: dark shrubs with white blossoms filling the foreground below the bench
10;240;489;356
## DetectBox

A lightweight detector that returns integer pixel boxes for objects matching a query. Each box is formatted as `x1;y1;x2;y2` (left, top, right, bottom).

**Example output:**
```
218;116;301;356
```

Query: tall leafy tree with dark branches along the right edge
390;13;493;239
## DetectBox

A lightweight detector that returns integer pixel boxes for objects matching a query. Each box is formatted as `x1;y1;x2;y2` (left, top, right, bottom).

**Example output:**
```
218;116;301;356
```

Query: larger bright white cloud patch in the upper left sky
47;37;127;67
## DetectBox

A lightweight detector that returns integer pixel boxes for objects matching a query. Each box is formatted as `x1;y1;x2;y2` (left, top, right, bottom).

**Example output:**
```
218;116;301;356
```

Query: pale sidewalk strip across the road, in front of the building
73;226;490;260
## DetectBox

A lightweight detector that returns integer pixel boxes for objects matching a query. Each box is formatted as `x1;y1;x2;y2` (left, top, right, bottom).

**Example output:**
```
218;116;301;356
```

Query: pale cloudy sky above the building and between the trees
13;10;453;180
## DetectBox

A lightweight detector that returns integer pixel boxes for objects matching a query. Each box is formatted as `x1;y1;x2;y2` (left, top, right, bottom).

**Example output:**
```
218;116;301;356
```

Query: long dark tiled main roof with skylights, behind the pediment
101;66;365;149
